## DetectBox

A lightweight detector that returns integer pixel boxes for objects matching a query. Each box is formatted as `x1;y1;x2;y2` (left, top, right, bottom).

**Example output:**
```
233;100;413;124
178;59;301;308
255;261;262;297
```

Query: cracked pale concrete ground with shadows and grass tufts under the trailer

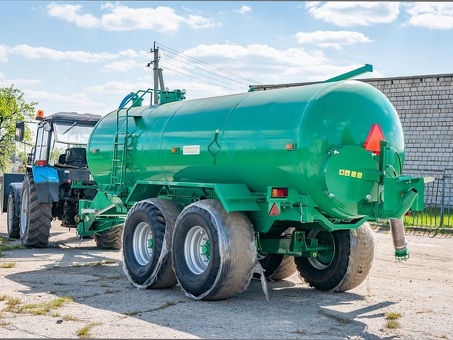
0;213;453;339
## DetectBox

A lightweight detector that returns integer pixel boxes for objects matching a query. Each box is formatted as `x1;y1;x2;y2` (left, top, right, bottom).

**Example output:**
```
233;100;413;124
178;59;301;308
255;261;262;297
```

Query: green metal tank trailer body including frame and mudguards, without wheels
80;74;423;233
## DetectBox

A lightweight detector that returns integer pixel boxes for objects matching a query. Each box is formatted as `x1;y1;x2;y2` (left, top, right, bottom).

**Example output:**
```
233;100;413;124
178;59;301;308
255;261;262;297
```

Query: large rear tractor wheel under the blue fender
19;174;52;248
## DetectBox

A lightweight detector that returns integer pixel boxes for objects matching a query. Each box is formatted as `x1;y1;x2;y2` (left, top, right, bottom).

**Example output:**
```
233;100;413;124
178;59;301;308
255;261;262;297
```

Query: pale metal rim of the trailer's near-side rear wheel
184;226;211;275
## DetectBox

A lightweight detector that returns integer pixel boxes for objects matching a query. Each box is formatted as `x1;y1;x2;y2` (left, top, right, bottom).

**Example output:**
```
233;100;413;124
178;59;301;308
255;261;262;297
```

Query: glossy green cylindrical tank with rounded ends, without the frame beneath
88;80;404;219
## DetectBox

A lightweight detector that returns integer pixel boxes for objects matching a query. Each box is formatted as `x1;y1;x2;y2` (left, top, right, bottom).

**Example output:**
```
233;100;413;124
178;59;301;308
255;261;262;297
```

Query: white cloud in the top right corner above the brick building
407;2;453;30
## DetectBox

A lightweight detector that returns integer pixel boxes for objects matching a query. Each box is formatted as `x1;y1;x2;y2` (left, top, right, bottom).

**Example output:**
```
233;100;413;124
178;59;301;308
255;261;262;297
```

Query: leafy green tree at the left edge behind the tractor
0;85;38;170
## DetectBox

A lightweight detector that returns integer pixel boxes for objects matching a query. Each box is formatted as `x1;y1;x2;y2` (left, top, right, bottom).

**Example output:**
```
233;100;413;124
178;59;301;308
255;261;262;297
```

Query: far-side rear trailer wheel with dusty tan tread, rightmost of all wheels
295;223;374;292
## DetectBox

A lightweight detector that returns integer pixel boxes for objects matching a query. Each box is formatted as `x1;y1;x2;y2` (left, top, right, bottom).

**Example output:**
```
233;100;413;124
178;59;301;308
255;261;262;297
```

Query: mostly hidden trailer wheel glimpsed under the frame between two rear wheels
253;253;297;281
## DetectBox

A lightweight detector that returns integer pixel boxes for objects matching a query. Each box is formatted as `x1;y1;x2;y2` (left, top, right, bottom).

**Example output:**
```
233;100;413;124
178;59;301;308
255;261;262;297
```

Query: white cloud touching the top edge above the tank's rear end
306;1;400;26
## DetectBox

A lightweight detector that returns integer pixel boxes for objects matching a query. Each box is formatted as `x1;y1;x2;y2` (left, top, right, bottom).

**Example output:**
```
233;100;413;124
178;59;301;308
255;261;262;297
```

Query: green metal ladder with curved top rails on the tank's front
108;89;155;196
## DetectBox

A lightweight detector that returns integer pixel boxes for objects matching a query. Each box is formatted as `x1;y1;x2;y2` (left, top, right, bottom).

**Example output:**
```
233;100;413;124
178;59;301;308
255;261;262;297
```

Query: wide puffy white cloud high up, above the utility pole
47;3;217;33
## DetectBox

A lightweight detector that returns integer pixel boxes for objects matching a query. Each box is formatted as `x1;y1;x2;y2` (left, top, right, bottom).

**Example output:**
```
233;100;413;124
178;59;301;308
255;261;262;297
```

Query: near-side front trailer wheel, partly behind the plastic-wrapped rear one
123;198;181;288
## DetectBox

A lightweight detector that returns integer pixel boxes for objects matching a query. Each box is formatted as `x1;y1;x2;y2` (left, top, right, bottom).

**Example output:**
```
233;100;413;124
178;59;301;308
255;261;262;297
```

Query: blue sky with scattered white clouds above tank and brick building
0;0;453;115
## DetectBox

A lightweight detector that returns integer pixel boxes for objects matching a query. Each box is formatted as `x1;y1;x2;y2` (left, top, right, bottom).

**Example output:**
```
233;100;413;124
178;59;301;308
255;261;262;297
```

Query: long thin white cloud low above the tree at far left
8;44;117;63
